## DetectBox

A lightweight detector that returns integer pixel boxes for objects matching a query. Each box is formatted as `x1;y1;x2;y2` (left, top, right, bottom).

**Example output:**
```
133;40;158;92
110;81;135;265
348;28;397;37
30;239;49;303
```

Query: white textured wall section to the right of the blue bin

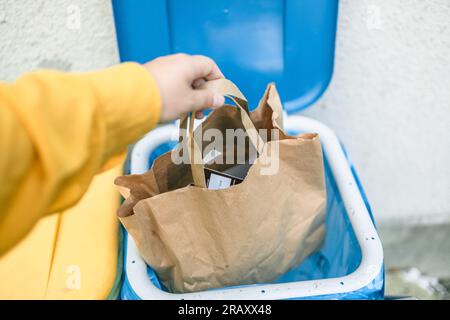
306;0;450;222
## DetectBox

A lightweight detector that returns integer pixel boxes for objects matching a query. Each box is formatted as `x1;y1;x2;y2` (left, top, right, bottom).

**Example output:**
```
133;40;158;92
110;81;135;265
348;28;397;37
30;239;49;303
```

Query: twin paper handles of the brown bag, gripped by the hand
180;79;265;188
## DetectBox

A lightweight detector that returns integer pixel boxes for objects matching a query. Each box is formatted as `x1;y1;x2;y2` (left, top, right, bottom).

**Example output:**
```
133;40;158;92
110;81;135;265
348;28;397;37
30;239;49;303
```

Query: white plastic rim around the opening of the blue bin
126;116;383;300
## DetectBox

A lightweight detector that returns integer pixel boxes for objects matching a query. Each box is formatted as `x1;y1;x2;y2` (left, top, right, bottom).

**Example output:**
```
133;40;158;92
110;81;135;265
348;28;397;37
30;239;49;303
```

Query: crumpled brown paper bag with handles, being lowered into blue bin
115;80;326;293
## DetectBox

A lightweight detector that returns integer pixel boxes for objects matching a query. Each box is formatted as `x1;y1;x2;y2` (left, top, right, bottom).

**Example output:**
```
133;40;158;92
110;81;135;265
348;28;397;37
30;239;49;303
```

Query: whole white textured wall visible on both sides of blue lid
0;0;450;222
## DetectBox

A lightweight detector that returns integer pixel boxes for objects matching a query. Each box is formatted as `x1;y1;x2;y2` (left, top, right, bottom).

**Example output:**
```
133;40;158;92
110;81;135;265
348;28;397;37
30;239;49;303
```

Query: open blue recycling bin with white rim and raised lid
113;0;384;299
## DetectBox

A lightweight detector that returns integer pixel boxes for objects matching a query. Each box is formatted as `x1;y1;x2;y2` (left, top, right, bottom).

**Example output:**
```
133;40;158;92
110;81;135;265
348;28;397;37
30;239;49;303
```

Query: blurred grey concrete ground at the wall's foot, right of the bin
379;224;450;299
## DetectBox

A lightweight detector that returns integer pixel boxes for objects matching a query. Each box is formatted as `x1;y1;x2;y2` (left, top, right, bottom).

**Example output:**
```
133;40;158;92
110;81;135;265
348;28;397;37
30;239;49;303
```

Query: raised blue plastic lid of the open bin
113;0;338;113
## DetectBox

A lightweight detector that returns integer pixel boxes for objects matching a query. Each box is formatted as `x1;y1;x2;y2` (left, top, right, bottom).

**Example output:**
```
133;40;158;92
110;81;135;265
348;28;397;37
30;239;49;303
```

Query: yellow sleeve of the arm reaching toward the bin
0;63;161;256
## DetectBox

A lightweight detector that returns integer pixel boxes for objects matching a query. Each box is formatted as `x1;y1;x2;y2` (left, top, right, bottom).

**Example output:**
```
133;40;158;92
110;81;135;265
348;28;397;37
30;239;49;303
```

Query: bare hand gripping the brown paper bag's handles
145;54;225;122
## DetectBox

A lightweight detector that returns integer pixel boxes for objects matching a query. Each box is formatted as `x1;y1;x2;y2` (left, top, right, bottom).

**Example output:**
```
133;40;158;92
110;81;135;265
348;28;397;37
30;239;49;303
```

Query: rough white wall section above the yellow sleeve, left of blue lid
0;0;119;80
